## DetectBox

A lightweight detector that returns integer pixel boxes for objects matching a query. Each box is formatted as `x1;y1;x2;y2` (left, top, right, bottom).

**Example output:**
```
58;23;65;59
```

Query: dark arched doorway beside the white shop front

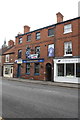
46;63;52;81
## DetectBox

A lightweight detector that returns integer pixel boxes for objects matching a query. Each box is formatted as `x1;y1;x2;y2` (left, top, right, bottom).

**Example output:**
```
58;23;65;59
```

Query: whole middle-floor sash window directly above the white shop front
64;42;72;56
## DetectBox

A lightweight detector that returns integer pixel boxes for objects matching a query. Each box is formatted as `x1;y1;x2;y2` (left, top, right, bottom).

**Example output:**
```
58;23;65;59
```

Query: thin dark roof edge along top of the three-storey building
16;17;80;38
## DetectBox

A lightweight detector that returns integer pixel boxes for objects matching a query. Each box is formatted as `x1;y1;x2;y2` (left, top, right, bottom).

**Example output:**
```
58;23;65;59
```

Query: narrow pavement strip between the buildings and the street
2;77;80;89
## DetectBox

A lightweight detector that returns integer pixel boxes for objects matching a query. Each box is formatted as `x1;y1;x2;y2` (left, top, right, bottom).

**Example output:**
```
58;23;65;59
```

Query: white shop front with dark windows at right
54;58;80;83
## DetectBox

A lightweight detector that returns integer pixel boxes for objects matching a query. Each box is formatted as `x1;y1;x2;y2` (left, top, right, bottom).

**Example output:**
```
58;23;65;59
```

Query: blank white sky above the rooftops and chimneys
0;0;80;47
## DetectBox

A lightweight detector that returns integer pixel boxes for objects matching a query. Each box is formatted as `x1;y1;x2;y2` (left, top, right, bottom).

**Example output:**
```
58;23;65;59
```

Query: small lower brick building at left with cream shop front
2;40;15;77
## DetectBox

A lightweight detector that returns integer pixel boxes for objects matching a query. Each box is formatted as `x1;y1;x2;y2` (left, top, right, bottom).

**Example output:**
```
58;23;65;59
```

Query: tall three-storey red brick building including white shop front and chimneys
4;12;80;83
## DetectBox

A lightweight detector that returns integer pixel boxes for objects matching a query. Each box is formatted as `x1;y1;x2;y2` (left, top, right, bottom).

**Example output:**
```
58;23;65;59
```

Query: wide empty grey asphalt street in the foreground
0;79;78;118
